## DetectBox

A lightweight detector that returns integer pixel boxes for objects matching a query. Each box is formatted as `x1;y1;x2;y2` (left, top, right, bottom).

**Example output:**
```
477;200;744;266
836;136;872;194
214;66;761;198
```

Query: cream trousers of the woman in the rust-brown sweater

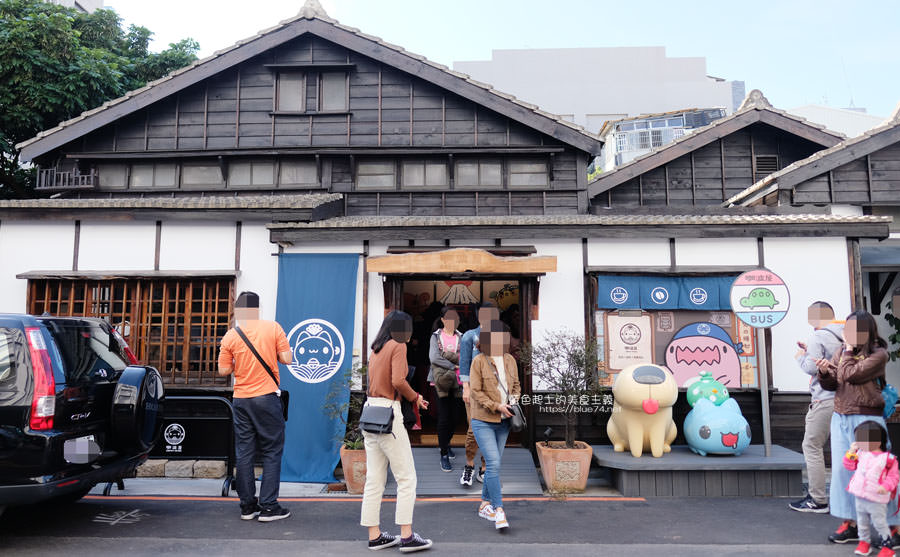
359;397;416;527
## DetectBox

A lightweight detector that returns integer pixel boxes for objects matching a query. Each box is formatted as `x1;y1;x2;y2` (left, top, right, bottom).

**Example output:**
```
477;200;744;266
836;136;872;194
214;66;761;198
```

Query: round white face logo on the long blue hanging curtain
287;319;344;383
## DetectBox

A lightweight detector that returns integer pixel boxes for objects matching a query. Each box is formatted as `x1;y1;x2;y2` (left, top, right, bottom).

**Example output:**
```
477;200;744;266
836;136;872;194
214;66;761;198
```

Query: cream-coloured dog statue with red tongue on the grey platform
606;364;678;458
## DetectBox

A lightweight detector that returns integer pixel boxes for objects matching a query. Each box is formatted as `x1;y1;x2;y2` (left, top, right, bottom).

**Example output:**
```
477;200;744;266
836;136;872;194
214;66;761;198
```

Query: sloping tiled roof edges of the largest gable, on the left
16;0;603;161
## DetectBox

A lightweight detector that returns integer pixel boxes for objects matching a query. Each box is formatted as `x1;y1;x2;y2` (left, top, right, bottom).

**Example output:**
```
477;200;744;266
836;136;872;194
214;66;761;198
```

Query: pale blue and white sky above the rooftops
105;0;900;117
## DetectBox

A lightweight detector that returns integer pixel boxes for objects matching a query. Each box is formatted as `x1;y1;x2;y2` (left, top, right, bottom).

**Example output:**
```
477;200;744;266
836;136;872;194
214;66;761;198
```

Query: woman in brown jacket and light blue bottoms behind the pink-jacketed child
816;310;900;543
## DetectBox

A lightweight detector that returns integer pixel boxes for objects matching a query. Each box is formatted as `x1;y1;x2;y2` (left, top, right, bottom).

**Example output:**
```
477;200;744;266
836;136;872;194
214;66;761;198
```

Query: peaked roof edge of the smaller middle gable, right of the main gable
588;89;845;201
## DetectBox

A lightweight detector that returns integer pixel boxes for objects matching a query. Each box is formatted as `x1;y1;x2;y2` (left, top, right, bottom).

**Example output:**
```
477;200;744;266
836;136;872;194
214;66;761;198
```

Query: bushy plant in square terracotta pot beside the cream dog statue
522;330;604;493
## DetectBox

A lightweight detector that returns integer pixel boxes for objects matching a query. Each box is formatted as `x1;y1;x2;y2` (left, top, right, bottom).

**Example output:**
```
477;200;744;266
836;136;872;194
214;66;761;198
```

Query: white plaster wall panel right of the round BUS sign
763;238;851;392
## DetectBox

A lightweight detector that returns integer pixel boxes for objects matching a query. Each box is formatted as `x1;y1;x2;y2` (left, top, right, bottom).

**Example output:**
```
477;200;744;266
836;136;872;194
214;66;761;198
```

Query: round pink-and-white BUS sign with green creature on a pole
731;269;791;329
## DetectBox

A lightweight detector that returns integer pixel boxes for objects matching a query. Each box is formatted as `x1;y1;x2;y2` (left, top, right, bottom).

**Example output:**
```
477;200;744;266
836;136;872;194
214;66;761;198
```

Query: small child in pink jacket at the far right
844;421;900;557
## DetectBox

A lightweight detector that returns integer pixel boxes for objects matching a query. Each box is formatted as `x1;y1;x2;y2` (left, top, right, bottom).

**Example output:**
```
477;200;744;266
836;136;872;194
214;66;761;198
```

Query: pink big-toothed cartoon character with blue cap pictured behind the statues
666;322;743;387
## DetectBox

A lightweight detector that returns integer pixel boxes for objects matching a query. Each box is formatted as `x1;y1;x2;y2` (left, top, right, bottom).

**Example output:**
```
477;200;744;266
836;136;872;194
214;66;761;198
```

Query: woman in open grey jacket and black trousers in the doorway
428;306;462;472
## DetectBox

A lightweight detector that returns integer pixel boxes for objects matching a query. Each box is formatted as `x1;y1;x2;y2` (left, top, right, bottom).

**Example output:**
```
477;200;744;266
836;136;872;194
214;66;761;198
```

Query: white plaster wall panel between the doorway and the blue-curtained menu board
531;239;585;391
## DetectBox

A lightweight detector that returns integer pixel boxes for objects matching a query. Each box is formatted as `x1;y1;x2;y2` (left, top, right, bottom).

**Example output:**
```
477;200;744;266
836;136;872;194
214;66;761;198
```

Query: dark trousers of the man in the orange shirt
233;393;284;509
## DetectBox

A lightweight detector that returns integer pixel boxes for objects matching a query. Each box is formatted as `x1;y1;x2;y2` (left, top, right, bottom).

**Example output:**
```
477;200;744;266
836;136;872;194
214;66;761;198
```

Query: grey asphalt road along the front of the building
0;496;853;557
